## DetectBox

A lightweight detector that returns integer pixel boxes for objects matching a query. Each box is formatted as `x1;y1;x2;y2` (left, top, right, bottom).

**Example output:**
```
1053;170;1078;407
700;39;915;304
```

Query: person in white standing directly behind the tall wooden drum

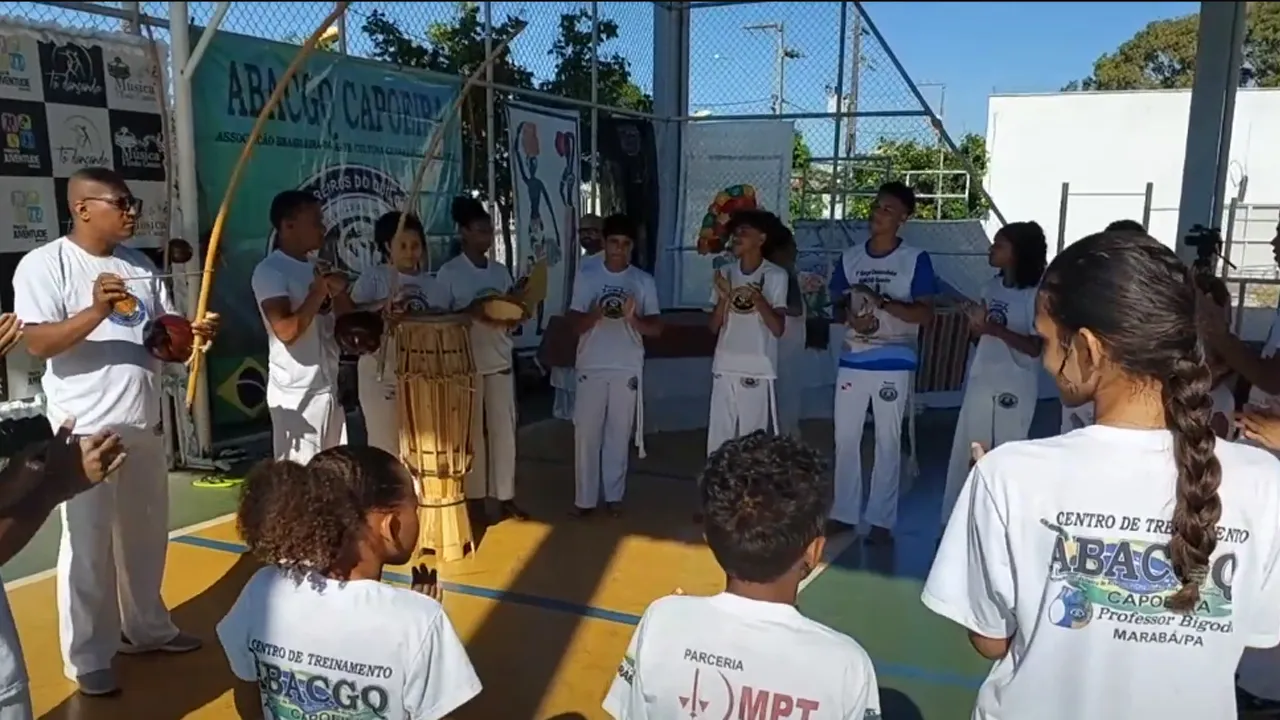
351;210;439;456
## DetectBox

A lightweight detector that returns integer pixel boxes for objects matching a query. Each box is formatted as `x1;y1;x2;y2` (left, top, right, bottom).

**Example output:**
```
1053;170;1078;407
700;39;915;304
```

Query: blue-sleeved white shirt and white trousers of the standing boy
831;238;938;528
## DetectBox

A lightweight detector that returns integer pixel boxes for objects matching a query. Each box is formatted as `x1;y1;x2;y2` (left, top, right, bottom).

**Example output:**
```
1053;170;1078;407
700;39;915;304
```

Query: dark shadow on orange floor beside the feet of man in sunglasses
41;555;261;720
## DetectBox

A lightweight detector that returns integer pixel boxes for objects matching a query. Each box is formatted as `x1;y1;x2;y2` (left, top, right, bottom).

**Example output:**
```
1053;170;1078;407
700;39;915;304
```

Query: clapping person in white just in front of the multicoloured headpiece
707;210;787;455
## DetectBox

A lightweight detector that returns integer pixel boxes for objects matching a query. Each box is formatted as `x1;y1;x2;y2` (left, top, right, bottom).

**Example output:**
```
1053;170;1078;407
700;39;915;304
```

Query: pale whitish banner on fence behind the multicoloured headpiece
676;120;795;307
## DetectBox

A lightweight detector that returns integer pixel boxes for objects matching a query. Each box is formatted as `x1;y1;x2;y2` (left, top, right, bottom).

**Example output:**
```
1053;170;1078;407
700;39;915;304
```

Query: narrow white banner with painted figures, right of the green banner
507;102;582;348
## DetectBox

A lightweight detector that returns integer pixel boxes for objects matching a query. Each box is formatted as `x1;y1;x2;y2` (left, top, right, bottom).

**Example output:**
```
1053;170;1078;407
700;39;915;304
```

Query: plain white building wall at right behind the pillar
987;90;1280;337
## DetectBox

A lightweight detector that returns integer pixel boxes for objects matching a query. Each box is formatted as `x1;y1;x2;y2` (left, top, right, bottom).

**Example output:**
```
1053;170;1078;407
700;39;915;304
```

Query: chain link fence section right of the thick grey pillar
689;3;989;220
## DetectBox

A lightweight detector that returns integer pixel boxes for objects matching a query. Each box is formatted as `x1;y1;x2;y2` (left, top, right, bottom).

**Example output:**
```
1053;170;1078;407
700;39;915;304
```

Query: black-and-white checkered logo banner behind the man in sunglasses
0;18;170;407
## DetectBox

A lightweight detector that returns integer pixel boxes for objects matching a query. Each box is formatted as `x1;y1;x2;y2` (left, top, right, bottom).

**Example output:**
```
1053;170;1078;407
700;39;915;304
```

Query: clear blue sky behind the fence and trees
17;1;1198;149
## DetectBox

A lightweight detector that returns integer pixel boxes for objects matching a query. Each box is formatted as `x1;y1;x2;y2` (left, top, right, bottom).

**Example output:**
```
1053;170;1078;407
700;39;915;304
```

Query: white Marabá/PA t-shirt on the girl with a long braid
922;425;1280;720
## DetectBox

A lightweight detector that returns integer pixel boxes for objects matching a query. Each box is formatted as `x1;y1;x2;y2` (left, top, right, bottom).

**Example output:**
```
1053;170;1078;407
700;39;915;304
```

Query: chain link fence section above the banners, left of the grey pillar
0;0;654;264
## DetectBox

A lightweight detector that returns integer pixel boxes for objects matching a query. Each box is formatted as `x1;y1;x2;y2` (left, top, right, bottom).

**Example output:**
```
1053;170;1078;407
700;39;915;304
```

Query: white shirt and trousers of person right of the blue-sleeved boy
942;275;1039;524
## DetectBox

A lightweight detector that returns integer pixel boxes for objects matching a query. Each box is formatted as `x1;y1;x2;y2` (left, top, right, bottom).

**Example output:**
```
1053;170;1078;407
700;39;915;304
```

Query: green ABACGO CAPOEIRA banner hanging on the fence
191;32;462;432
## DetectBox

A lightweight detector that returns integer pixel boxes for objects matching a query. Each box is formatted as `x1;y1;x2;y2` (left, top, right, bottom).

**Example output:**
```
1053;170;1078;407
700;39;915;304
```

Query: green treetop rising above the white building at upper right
1062;3;1280;91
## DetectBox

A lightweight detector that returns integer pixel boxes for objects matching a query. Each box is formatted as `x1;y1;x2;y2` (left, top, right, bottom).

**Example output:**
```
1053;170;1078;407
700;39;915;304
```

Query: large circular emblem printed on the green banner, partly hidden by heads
266;164;409;275
